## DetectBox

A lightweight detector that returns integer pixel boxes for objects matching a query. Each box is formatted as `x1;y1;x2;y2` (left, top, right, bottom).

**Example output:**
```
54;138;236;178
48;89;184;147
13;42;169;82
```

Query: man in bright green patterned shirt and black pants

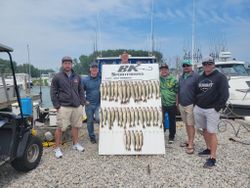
160;64;178;144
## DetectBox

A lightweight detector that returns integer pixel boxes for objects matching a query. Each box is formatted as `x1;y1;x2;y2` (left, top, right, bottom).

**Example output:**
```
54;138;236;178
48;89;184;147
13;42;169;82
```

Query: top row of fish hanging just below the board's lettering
101;80;160;104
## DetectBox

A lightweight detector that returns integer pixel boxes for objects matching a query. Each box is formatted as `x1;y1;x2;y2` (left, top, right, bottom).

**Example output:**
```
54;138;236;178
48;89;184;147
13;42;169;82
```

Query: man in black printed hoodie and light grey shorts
194;56;229;168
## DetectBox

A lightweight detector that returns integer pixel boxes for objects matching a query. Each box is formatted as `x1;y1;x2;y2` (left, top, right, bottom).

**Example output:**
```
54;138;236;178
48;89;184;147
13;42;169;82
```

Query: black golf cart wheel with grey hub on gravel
11;136;43;172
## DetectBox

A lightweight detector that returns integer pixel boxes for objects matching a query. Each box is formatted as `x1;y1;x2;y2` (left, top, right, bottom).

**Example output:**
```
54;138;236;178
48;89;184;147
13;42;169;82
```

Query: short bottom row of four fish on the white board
124;130;144;151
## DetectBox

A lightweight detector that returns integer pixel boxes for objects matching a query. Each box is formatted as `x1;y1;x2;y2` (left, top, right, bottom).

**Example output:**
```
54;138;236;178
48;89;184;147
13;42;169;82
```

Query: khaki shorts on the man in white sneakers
57;105;83;131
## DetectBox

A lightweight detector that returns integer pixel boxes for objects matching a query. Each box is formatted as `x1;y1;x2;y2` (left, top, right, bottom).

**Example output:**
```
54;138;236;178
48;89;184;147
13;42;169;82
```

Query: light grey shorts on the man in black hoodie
194;106;220;133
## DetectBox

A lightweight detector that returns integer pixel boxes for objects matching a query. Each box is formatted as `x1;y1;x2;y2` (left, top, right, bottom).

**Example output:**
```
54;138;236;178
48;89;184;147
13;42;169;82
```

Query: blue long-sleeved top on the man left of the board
82;75;101;106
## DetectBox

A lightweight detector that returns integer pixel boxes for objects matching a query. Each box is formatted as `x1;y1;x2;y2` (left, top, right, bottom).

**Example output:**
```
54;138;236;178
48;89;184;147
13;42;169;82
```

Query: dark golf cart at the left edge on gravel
0;44;43;172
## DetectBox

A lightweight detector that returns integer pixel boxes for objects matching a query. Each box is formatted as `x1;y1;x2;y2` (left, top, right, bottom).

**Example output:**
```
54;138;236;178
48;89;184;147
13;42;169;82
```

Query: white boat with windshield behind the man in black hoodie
198;51;250;118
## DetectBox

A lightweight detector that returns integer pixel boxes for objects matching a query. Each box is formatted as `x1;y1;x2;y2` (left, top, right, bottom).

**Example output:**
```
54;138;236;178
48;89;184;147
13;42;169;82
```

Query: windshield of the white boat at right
216;64;249;76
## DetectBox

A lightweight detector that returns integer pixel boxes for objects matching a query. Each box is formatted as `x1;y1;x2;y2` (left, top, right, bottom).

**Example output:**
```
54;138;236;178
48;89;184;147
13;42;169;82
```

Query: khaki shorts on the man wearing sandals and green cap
179;104;194;126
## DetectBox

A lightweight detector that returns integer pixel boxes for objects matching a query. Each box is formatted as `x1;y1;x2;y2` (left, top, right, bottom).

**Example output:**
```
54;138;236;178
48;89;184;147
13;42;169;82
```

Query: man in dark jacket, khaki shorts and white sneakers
50;56;85;158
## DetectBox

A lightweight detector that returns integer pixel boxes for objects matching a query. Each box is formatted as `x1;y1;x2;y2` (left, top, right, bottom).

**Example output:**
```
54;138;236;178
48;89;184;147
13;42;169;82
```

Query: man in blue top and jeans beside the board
82;62;101;144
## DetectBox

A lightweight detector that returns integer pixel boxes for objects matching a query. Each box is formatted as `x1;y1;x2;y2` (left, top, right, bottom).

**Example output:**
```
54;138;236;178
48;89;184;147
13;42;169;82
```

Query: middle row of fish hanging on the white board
99;107;163;129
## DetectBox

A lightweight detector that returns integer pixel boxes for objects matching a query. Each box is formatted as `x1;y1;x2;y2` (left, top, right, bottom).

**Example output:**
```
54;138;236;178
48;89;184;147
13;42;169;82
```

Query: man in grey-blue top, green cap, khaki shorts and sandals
178;60;199;154
